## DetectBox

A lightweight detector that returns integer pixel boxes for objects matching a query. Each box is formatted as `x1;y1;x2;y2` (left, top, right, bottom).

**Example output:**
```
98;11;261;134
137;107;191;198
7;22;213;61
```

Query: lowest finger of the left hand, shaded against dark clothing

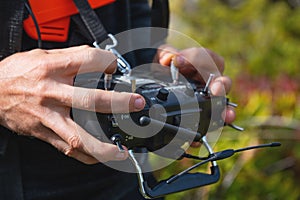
33;127;99;164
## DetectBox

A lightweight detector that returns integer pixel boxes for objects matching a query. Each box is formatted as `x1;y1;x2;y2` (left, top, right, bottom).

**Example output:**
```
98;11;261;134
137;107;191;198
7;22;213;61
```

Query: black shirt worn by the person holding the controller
0;0;164;200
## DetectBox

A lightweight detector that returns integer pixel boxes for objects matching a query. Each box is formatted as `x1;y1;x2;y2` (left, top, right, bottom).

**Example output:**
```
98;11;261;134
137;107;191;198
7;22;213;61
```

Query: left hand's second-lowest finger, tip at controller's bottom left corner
43;113;128;162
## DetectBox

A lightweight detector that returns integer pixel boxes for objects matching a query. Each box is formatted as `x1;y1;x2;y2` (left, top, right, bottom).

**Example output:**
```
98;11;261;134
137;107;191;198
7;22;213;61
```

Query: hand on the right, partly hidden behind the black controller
156;45;235;124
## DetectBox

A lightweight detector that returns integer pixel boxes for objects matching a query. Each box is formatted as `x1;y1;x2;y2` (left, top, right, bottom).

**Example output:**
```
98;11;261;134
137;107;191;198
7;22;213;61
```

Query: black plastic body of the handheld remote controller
97;76;226;151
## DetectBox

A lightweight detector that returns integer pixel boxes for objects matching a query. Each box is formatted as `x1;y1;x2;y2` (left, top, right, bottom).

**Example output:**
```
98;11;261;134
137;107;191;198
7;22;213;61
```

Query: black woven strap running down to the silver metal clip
73;0;107;44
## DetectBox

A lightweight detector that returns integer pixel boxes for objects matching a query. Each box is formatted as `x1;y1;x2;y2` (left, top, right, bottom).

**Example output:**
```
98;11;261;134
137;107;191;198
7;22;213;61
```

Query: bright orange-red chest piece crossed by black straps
23;0;115;42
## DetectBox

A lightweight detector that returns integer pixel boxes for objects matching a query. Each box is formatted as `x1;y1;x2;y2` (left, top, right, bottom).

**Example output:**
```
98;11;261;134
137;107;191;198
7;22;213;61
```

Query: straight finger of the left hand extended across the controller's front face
58;85;145;113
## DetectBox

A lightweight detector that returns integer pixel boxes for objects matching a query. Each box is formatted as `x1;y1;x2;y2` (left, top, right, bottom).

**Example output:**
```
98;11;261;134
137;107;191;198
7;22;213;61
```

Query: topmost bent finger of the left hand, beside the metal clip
43;46;116;75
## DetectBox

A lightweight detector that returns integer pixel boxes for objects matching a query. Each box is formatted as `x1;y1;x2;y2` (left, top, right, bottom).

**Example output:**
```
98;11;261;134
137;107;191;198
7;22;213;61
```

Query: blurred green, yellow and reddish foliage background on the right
157;0;300;200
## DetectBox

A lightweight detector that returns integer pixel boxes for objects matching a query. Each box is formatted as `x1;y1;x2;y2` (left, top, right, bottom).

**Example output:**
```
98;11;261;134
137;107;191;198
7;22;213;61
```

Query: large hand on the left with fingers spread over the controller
0;46;145;164
